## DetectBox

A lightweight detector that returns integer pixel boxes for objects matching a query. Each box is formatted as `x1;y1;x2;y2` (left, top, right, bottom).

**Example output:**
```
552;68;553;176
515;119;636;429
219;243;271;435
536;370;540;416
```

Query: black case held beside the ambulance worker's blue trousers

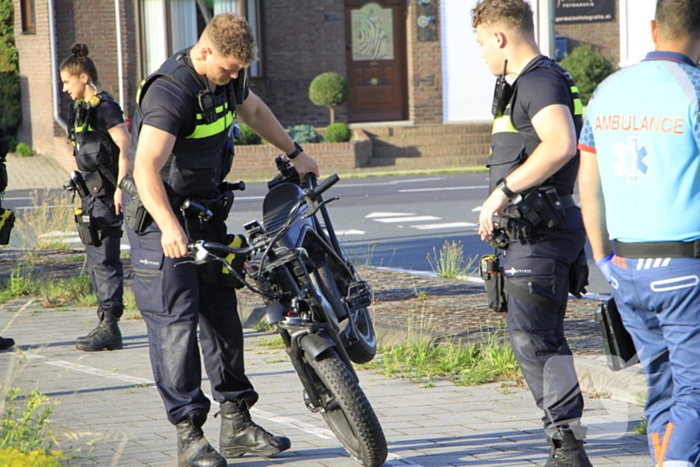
595;298;639;371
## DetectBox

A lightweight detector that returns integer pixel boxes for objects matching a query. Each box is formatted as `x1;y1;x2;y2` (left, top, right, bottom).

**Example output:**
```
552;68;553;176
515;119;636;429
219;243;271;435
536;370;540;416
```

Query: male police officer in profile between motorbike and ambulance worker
472;0;591;467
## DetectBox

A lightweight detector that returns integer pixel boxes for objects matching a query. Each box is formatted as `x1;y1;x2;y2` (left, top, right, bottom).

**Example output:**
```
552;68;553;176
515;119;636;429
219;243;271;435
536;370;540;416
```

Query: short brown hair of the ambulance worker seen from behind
654;0;700;39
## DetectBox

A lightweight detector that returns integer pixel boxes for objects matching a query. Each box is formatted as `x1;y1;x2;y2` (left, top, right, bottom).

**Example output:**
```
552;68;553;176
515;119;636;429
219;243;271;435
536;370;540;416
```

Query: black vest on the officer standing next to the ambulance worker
486;57;583;195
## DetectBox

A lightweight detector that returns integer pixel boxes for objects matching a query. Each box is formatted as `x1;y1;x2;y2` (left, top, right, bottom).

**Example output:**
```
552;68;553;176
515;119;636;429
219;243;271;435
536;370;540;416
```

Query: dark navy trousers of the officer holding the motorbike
128;219;253;424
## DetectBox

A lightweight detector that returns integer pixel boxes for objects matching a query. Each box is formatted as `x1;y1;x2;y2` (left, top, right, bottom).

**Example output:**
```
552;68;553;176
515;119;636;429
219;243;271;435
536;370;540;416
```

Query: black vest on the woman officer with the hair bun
68;91;119;178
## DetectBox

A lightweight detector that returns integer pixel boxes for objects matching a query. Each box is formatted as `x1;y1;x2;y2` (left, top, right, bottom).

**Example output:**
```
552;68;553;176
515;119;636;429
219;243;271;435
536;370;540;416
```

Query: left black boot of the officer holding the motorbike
175;409;228;467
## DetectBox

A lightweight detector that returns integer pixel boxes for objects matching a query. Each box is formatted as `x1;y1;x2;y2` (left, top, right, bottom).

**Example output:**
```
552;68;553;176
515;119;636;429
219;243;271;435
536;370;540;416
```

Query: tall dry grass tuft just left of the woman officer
17;191;75;249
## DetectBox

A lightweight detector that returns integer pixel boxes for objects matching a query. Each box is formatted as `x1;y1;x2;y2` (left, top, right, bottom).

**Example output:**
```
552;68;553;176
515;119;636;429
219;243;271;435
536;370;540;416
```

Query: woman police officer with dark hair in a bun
60;43;131;352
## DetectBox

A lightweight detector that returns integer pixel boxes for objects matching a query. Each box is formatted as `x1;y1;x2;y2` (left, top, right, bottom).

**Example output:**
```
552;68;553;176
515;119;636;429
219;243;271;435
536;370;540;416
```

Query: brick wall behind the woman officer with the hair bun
14;0;138;172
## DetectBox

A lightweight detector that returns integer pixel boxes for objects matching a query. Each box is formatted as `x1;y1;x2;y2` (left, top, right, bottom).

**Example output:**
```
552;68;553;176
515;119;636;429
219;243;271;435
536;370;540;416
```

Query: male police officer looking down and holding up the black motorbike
127;13;318;467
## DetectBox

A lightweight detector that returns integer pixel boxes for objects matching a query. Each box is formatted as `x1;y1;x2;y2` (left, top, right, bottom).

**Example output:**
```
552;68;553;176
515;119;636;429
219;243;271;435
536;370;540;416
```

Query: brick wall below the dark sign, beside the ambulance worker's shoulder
555;0;620;67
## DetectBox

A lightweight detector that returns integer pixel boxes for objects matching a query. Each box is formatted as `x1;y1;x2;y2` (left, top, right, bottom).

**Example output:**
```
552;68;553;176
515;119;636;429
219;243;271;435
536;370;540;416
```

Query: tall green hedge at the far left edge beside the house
0;0;22;137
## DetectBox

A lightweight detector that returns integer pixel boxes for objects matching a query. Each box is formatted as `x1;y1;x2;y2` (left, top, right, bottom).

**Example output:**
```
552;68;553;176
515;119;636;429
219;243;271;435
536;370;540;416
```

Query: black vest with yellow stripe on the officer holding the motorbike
131;49;242;201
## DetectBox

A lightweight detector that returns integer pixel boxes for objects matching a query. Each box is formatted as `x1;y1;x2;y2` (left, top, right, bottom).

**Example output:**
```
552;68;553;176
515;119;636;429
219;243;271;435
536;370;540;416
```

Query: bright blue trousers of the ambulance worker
610;256;700;467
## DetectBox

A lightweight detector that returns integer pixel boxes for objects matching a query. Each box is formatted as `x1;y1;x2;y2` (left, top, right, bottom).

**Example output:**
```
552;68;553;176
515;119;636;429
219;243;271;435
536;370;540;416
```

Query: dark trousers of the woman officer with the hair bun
82;196;124;318
